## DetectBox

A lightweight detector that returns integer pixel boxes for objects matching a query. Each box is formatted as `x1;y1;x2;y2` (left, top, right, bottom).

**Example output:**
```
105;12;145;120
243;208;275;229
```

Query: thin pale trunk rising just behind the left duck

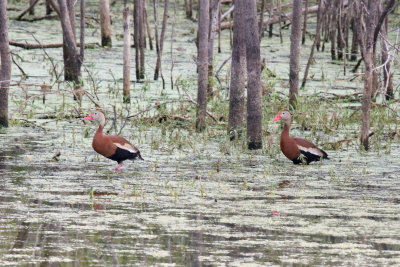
123;6;131;103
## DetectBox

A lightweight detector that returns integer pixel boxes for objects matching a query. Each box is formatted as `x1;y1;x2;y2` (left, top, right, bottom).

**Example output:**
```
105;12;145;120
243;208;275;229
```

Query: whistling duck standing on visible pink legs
83;110;143;172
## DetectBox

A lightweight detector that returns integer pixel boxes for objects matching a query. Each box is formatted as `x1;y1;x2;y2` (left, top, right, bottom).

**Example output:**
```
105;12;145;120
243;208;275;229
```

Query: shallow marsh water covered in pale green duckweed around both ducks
0;2;400;266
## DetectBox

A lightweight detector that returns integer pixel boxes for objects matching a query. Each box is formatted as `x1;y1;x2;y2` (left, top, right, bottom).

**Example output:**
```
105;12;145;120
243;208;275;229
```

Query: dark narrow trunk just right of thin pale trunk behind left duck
133;0;145;80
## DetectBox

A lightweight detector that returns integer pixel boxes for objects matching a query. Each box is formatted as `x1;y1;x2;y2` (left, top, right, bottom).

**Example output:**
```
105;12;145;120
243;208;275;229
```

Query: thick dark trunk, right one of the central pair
244;0;262;149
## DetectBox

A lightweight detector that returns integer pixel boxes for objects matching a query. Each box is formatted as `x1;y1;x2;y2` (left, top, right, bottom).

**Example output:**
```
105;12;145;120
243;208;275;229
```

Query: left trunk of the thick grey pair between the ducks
228;0;246;140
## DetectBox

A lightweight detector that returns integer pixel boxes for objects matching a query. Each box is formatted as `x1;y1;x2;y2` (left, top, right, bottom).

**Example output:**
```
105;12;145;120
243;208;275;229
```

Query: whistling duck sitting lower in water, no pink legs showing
274;110;328;164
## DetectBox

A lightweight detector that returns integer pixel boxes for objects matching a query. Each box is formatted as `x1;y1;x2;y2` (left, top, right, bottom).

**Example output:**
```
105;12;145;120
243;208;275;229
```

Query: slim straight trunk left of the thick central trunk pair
196;0;210;132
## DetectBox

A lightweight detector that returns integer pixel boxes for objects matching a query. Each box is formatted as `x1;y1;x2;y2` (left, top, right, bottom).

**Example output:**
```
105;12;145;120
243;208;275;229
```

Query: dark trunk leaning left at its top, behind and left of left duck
58;0;82;105
